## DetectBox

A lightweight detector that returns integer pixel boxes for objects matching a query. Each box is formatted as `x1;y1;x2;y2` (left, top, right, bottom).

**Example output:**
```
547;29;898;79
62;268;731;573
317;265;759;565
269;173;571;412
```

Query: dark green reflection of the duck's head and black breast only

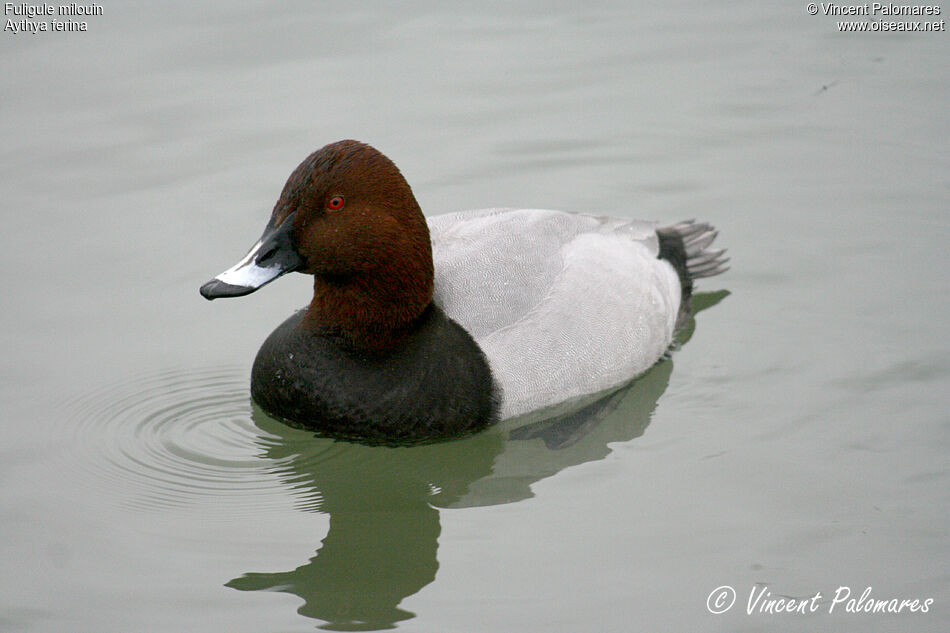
228;414;504;630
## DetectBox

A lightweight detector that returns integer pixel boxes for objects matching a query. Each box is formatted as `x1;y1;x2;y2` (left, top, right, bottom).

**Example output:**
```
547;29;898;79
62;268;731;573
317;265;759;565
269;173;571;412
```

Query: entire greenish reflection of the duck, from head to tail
228;293;725;630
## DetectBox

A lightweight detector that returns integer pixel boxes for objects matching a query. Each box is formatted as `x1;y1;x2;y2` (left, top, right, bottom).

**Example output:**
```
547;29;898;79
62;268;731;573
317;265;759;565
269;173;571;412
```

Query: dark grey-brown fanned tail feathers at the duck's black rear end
656;220;729;303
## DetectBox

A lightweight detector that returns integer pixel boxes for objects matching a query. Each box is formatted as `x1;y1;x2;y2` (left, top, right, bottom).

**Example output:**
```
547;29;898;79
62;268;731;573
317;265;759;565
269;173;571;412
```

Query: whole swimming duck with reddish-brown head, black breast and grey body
200;140;728;444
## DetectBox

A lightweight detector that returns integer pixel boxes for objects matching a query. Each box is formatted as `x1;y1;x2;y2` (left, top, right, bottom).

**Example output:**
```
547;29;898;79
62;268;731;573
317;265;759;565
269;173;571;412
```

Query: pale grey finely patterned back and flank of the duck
428;209;681;418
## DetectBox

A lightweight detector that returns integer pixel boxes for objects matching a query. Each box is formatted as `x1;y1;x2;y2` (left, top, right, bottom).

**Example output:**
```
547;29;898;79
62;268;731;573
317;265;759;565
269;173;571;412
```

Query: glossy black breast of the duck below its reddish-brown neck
251;305;498;444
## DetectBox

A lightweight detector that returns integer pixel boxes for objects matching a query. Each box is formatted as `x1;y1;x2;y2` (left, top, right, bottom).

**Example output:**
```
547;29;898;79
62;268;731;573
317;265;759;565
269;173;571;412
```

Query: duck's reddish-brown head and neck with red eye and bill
201;141;433;346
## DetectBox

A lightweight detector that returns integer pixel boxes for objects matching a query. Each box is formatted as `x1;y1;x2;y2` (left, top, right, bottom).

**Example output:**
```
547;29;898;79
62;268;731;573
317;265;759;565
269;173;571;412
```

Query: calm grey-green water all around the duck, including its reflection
0;2;950;632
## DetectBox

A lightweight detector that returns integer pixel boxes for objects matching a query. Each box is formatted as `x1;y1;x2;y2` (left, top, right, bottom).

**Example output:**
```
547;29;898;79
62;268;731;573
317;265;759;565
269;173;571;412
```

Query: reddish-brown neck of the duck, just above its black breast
301;243;433;352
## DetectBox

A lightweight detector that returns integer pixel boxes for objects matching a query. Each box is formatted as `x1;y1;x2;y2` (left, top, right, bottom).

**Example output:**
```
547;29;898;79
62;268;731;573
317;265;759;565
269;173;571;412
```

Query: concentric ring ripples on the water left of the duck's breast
58;369;308;517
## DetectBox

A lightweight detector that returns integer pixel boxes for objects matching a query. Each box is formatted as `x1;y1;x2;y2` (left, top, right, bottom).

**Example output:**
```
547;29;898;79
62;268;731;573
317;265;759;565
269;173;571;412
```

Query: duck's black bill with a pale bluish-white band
200;215;303;300
